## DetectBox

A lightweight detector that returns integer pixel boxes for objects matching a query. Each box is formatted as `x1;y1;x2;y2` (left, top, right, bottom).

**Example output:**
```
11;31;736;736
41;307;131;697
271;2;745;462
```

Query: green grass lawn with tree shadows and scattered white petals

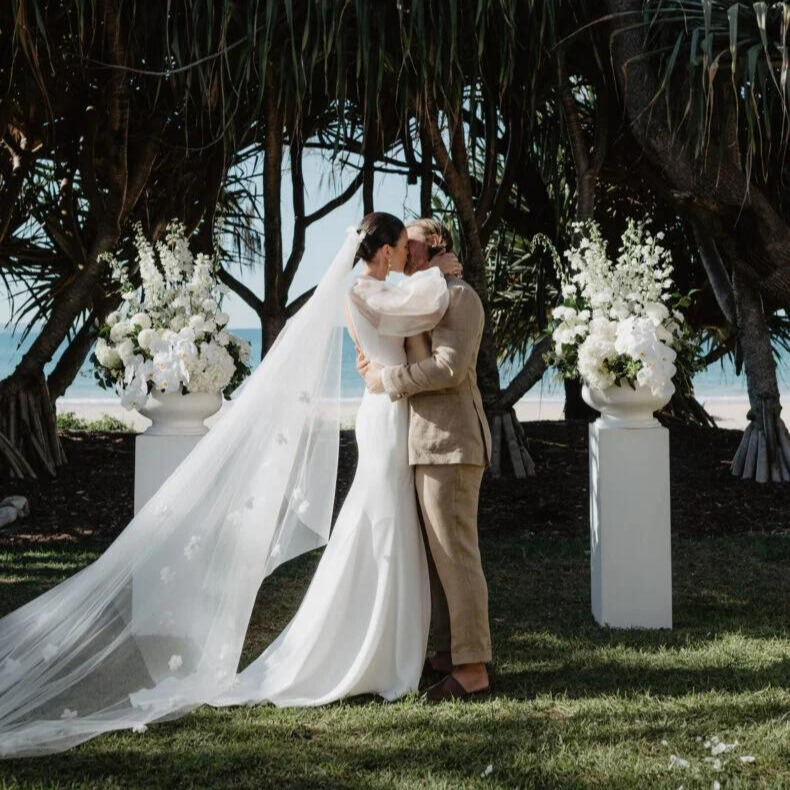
0;531;790;790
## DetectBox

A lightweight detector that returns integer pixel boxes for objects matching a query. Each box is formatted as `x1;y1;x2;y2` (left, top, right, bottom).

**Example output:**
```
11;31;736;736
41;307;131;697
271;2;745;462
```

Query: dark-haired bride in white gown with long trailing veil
0;212;458;757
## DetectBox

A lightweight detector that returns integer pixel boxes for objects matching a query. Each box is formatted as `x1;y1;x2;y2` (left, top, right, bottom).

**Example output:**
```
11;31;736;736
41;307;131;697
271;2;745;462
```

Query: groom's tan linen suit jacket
381;277;491;466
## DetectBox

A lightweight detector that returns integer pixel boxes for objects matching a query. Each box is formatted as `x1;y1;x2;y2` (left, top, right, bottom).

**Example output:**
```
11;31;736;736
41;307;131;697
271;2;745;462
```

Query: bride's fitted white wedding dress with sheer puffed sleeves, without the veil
212;269;447;706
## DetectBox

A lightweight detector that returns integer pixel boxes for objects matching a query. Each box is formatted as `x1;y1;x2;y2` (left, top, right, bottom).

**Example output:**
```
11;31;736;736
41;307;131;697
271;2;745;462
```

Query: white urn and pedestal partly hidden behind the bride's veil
134;392;222;515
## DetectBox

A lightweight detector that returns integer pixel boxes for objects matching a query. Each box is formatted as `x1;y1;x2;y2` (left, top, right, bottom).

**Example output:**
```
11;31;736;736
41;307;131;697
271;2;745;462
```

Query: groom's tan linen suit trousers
414;464;491;665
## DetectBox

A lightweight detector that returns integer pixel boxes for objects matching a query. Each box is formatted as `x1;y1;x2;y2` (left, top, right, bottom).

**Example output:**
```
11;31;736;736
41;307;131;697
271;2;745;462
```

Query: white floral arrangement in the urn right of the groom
547;220;695;397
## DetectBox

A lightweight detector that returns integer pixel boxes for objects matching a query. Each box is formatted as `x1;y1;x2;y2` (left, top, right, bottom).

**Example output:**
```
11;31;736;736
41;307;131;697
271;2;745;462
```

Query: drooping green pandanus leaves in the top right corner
643;0;790;194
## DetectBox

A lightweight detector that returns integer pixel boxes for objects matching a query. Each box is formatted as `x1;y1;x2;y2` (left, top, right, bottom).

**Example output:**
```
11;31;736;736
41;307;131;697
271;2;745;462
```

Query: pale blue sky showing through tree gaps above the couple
0;151;420;329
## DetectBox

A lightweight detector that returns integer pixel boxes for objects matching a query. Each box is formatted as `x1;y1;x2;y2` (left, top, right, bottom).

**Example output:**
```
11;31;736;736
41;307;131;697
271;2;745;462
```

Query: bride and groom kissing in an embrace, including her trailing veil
0;212;491;757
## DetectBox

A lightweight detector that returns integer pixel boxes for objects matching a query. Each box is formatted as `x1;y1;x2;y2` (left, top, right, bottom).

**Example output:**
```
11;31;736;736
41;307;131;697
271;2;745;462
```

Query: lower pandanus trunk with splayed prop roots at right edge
732;270;790;483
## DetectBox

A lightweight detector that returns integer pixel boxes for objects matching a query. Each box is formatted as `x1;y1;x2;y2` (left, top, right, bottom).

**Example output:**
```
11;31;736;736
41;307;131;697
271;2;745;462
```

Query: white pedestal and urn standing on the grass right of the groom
582;384;672;628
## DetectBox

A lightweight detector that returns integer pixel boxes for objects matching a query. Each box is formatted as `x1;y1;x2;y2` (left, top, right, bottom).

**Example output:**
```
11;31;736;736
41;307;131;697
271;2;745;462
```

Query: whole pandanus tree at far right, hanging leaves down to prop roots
601;0;790;482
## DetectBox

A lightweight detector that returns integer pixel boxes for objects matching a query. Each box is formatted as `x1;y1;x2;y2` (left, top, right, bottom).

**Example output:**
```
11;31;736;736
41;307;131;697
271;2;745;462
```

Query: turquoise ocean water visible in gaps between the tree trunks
0;329;790;400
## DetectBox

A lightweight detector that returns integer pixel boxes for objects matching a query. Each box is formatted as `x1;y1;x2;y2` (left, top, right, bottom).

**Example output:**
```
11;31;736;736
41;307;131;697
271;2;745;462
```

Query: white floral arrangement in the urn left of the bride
92;220;251;409
